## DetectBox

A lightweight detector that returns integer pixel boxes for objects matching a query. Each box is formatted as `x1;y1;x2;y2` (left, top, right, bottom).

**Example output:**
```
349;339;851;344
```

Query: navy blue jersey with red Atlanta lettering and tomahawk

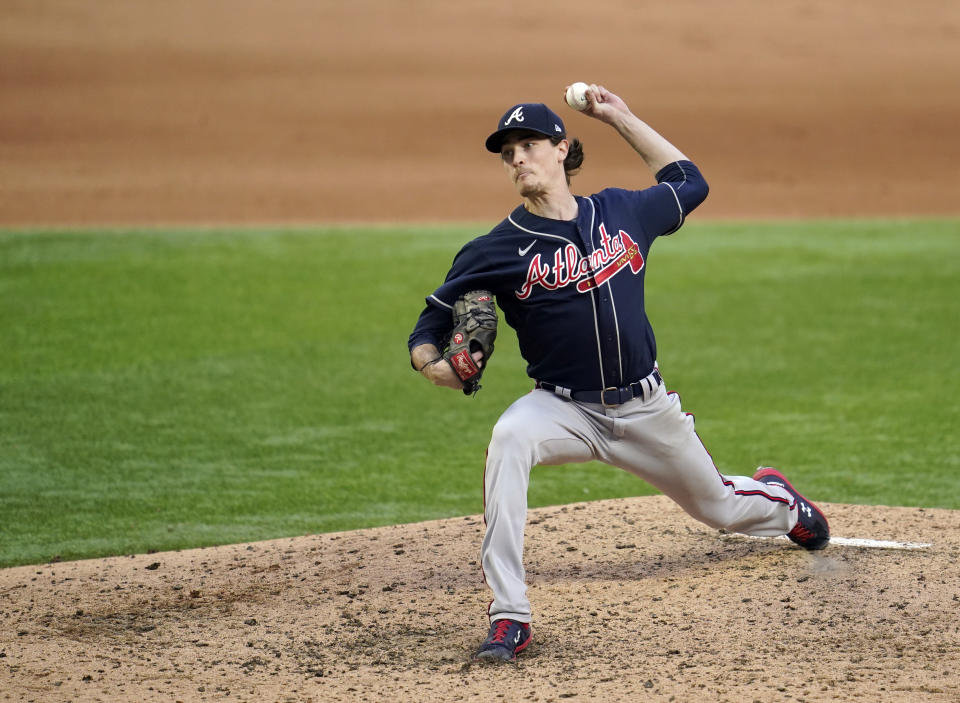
409;161;707;390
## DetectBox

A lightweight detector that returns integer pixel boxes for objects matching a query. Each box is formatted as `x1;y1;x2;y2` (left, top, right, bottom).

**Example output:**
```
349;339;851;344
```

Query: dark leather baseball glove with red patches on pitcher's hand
443;290;497;395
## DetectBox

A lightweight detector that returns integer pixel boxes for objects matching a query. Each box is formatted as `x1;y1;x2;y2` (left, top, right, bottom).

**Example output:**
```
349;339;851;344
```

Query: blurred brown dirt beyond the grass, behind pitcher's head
0;0;960;225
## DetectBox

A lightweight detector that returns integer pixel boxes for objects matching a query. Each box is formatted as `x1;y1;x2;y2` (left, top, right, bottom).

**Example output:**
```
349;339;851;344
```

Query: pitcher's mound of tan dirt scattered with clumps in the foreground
0;497;960;703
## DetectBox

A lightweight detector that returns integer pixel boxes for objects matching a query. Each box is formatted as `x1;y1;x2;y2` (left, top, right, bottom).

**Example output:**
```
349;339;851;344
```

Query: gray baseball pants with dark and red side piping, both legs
480;372;797;622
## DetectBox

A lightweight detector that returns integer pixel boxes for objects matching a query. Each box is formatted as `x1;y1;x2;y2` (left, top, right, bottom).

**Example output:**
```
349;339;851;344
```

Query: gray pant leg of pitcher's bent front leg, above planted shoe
480;390;595;623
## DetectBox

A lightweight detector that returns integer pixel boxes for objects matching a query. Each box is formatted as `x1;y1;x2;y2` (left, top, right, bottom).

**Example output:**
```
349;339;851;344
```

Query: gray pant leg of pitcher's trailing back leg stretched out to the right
603;386;797;537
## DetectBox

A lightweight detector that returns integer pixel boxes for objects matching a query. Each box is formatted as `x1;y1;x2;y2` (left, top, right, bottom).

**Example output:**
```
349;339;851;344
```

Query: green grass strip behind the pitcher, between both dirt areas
0;221;960;565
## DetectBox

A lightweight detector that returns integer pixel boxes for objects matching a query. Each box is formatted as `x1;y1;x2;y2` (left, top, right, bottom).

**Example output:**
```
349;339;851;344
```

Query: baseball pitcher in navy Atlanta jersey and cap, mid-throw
409;84;830;661
